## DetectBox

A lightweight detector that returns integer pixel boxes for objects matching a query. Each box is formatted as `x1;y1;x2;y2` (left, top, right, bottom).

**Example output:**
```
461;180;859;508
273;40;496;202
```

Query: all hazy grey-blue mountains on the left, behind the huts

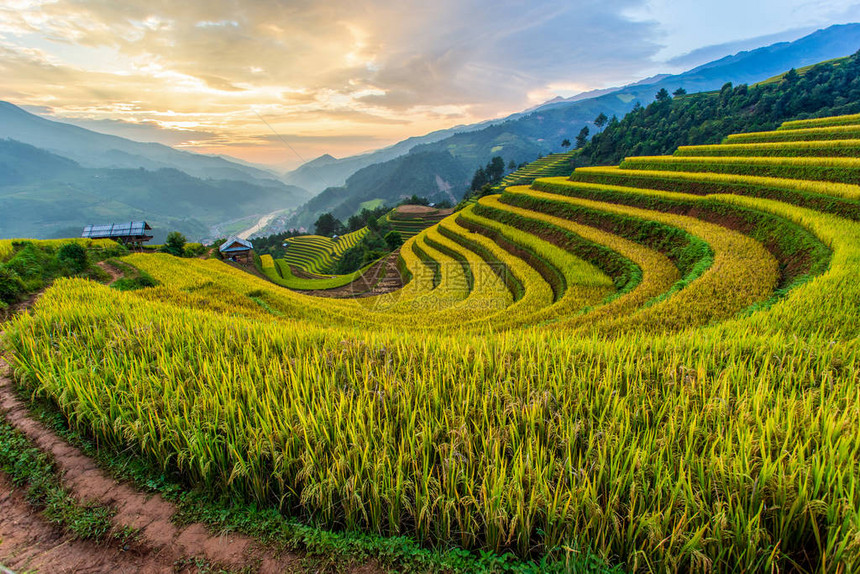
0;102;311;241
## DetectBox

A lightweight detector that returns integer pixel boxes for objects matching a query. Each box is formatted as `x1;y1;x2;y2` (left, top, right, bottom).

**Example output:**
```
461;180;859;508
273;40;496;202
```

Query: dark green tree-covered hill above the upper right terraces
577;52;860;165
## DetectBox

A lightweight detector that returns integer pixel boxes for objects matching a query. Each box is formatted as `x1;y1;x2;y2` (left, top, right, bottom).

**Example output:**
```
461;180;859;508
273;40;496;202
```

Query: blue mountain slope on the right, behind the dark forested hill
282;24;860;232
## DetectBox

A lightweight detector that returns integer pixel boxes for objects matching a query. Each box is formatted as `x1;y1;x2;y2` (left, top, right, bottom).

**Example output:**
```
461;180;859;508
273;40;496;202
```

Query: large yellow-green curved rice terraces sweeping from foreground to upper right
0;116;860;572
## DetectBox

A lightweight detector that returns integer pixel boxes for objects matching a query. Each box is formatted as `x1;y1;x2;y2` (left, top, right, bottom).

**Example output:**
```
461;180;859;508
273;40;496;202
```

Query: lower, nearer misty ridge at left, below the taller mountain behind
0;139;307;242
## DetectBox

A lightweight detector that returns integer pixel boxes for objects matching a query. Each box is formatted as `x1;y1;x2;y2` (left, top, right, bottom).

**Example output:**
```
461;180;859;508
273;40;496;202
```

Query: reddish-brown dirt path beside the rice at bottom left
0;300;383;574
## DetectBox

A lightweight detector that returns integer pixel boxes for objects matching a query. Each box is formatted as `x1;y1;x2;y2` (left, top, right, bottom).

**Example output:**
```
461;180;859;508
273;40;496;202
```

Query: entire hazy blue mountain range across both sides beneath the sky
0;24;860;240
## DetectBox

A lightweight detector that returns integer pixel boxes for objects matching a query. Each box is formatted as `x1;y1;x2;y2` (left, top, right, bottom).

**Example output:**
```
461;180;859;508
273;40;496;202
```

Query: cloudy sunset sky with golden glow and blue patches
0;0;860;169
